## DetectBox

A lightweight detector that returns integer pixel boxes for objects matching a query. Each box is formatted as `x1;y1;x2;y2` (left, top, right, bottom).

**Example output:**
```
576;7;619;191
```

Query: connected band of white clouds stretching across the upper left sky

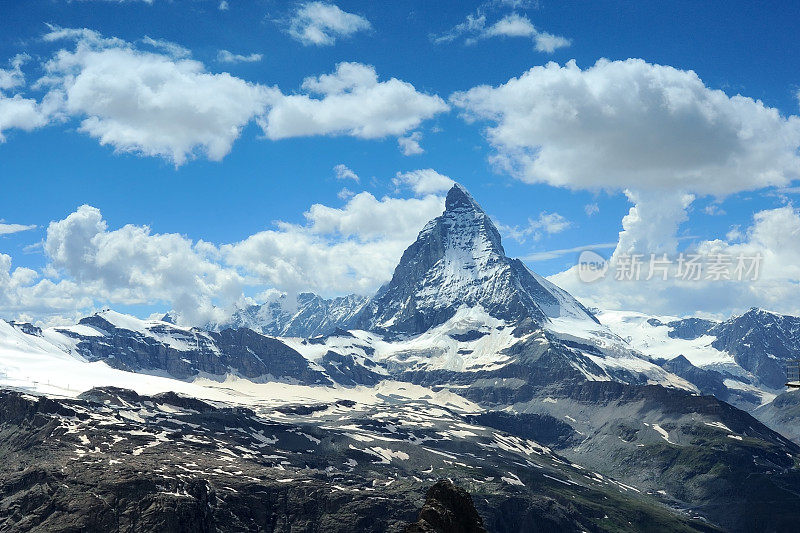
0;26;449;159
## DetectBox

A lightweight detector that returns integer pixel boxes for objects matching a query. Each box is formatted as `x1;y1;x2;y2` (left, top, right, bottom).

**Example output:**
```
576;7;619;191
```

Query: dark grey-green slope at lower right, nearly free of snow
500;382;800;531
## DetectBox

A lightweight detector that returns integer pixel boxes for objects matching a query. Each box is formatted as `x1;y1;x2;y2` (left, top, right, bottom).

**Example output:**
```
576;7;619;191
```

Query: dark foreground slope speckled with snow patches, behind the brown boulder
0;387;720;533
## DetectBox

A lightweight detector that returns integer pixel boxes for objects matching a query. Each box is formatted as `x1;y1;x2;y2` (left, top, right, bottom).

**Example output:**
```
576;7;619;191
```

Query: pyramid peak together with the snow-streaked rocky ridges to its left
0;185;696;390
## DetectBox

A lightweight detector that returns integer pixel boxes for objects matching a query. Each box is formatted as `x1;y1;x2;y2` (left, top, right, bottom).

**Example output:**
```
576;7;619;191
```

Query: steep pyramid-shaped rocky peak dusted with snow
354;185;594;333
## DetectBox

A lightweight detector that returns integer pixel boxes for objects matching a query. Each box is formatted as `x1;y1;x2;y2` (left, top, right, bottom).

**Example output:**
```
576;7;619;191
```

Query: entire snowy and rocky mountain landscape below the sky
0;185;800;532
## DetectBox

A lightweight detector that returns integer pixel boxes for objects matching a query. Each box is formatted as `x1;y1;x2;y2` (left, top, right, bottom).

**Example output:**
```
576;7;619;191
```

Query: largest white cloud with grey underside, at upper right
451;59;800;195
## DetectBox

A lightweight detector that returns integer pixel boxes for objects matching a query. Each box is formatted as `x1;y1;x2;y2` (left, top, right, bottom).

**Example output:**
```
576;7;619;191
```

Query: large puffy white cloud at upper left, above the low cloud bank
40;28;278;165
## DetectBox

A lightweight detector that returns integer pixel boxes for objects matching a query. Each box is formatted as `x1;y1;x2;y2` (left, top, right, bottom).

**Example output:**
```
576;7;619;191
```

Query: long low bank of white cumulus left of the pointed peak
0;192;444;325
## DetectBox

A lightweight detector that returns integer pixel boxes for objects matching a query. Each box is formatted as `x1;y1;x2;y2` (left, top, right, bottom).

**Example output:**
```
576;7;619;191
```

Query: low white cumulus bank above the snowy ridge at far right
550;206;800;316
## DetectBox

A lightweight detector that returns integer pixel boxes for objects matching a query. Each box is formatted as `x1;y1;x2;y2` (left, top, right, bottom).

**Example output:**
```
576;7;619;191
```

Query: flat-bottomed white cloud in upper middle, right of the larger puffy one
260;63;449;139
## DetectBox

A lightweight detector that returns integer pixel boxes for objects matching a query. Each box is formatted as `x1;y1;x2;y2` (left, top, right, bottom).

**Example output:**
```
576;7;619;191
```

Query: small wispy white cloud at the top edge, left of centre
289;2;372;46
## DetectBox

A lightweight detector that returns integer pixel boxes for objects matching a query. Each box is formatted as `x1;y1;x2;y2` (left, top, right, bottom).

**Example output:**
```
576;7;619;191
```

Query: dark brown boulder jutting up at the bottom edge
405;479;486;533
